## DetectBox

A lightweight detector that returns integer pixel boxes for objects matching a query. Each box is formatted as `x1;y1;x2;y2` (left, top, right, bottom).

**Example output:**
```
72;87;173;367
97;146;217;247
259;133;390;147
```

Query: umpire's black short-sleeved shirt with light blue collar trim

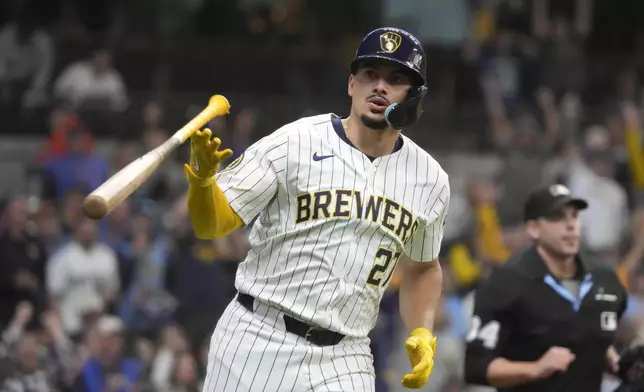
465;247;626;392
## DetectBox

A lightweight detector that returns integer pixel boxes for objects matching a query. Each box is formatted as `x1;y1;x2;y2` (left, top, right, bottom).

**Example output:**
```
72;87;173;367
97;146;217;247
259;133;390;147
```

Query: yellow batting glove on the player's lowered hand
402;328;436;389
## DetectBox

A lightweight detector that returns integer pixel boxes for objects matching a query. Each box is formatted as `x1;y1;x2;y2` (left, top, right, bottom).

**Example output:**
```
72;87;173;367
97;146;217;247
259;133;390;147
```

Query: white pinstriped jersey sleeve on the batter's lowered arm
405;173;450;262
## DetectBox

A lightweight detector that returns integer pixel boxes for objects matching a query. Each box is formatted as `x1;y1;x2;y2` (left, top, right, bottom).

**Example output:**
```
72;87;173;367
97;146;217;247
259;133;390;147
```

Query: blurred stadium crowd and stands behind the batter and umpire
0;0;644;392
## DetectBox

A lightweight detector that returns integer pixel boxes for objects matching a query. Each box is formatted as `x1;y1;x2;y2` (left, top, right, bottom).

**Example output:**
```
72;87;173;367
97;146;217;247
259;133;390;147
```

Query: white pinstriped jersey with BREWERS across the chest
217;114;450;337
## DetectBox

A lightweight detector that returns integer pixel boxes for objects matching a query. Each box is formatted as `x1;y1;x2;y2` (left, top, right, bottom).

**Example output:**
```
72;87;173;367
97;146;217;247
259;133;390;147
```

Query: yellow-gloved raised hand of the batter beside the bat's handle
186;129;233;179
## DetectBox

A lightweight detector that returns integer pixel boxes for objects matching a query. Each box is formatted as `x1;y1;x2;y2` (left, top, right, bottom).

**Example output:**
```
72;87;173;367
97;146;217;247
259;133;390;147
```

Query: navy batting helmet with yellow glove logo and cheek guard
351;27;427;129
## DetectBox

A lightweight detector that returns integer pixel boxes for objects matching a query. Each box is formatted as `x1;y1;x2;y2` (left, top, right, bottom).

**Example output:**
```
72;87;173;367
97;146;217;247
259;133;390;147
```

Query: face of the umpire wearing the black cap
534;206;581;257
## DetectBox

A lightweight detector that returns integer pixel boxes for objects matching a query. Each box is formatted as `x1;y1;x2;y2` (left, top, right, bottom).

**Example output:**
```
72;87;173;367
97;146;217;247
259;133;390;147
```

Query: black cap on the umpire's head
524;184;588;221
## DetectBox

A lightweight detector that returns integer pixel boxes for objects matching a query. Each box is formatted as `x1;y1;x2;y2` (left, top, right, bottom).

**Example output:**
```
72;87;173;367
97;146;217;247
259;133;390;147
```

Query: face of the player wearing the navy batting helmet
349;61;411;130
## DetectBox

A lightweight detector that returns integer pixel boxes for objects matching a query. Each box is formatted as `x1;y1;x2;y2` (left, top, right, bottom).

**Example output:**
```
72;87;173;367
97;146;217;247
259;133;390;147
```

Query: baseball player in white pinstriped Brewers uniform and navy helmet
185;28;450;392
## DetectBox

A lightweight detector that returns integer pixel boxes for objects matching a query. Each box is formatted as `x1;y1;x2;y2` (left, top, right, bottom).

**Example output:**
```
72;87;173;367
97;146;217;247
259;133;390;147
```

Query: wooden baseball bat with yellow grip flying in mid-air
83;95;230;219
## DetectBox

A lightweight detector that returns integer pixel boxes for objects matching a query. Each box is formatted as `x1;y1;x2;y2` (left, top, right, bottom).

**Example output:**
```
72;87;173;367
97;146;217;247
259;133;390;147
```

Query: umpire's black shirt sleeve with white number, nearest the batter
464;267;516;385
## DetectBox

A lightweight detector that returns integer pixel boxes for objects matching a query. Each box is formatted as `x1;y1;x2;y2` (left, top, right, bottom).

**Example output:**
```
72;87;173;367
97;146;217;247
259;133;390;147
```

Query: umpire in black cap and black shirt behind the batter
465;185;626;392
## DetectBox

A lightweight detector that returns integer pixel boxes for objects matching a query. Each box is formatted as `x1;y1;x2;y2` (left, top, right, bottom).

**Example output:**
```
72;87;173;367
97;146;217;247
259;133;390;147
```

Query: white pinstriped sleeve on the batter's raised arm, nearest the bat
217;133;288;225
